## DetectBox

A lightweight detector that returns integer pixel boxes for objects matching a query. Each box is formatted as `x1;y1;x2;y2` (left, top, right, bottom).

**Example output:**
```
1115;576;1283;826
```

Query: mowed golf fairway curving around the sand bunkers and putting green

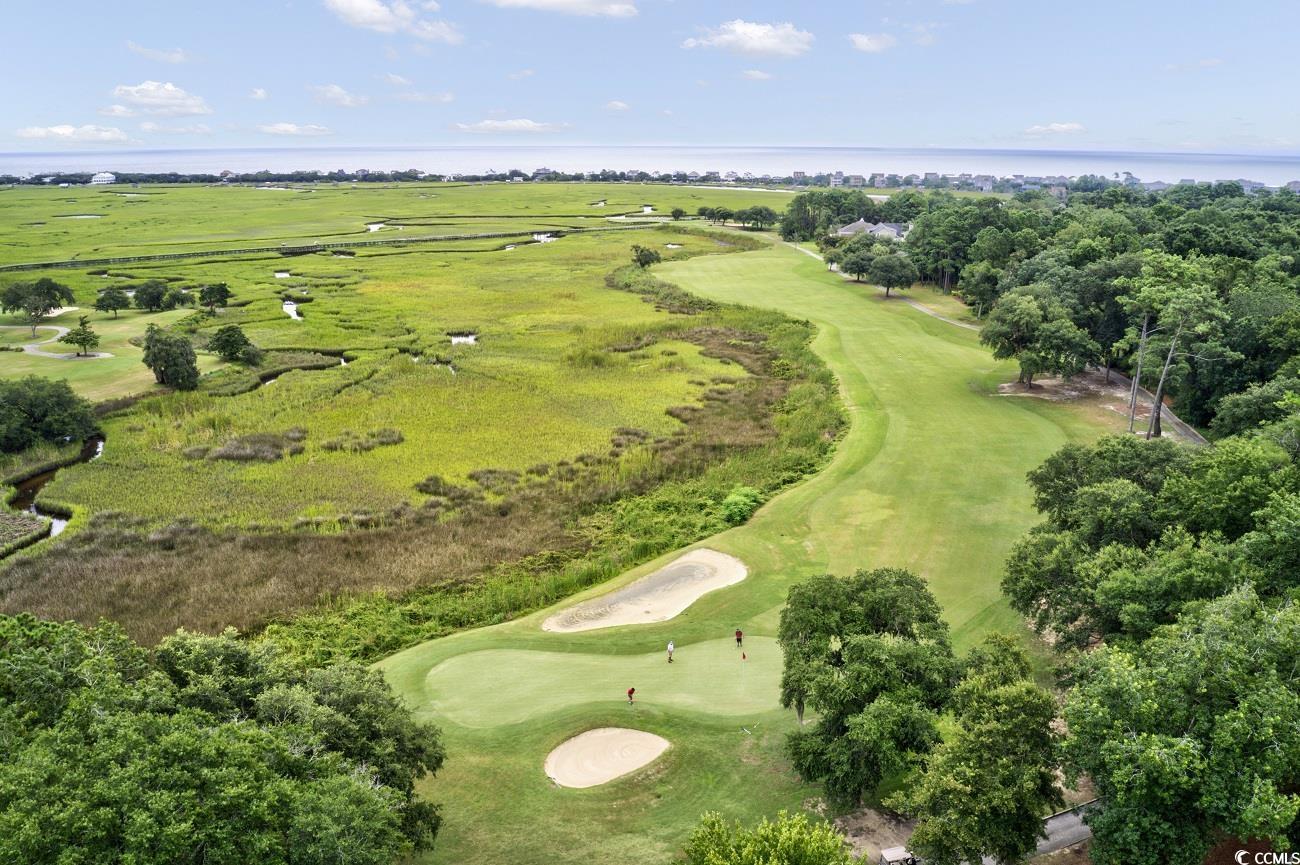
378;238;1123;865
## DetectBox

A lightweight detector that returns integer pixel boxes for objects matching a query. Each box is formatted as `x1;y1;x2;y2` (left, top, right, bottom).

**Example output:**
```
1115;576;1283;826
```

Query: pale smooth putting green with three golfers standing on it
424;637;781;728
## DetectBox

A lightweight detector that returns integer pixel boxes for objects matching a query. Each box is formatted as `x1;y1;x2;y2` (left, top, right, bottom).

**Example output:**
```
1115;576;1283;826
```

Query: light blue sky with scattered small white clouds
0;0;1300;152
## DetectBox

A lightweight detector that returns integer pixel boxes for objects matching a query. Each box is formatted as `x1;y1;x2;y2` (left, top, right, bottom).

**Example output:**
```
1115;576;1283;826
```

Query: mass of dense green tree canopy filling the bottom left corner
0;617;443;865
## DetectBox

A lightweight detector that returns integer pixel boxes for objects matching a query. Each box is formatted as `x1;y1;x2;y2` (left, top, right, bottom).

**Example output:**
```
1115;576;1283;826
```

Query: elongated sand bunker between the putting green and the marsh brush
542;550;749;633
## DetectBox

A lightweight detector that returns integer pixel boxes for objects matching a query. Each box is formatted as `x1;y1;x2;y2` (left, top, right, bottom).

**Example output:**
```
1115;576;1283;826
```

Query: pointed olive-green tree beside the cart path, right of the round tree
891;635;1063;865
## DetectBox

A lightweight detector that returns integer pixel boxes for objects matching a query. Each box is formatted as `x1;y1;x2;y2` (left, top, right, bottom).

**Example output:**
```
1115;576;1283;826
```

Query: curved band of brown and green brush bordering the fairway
0;266;844;650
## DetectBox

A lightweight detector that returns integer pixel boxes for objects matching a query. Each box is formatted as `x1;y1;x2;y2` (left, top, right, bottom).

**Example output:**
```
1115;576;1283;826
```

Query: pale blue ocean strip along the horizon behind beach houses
0;146;1300;186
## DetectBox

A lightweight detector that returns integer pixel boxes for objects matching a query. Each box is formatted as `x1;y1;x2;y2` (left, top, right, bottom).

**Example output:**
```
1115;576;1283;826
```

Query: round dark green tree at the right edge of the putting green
777;568;954;806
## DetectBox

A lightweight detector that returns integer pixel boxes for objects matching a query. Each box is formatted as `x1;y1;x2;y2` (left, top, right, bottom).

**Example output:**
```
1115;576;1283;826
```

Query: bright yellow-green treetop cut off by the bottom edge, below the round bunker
685;810;863;865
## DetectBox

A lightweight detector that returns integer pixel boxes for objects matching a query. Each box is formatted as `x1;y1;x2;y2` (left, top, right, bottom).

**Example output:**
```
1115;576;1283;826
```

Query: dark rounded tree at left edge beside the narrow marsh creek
0;376;99;454
